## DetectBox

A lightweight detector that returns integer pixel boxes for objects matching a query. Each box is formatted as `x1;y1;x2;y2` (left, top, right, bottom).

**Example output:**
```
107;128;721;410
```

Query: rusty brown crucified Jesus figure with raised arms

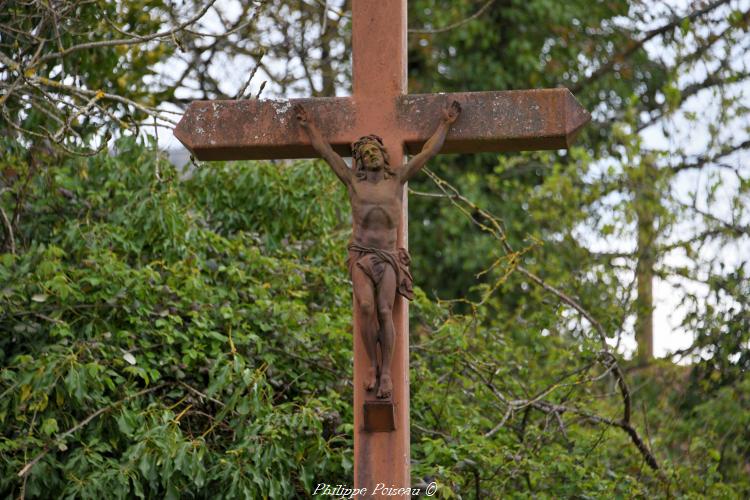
295;101;461;399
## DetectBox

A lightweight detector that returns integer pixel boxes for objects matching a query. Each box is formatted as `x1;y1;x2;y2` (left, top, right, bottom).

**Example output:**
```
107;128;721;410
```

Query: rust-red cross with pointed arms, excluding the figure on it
174;0;589;497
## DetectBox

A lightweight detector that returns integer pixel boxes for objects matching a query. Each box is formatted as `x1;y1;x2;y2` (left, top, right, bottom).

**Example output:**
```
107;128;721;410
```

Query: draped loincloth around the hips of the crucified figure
348;243;414;300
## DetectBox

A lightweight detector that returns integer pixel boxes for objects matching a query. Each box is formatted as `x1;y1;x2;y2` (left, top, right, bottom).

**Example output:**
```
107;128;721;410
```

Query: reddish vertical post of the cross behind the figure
352;0;411;495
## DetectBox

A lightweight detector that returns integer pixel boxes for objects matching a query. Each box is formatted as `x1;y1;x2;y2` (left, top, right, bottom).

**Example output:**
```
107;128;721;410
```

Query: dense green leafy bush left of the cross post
0;140;352;498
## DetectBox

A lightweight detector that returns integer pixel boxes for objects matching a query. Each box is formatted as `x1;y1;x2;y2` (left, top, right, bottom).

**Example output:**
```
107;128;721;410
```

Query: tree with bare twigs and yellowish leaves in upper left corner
0;0;259;253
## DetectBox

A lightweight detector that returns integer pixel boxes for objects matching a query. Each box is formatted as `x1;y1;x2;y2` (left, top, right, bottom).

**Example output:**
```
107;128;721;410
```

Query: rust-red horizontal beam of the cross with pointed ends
175;88;589;160
